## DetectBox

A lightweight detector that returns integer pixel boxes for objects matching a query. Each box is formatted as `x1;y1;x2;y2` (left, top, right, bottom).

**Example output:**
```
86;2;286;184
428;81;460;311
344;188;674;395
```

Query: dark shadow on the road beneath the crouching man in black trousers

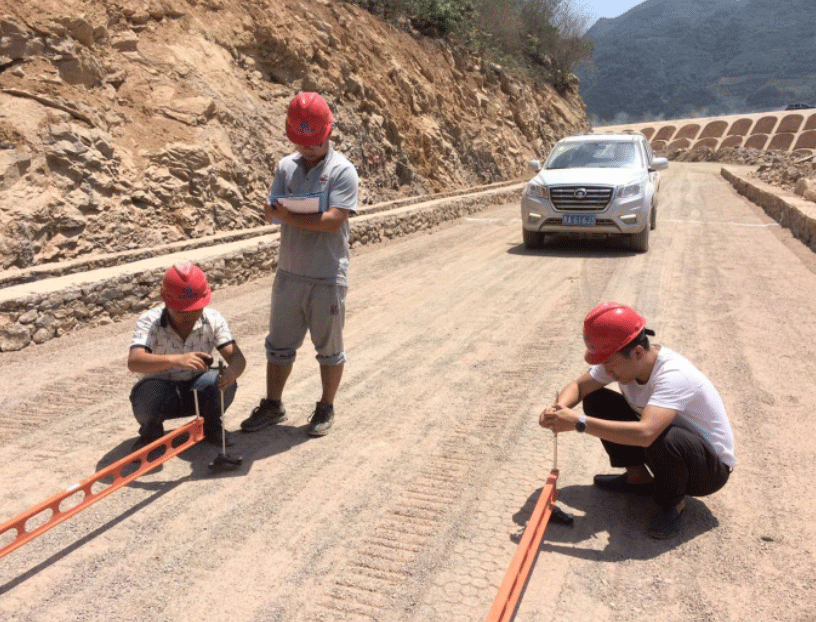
513;486;719;562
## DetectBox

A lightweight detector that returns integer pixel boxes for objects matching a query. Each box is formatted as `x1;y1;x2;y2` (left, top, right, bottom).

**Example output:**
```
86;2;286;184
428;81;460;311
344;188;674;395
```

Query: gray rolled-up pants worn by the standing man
265;272;348;366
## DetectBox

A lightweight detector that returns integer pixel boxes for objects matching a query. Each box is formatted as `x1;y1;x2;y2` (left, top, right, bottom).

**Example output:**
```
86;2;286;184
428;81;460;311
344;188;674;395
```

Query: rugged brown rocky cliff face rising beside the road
0;0;588;270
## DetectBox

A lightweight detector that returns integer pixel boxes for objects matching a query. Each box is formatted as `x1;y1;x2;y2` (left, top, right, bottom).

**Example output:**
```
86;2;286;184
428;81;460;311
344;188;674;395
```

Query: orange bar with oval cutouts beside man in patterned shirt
0;417;204;558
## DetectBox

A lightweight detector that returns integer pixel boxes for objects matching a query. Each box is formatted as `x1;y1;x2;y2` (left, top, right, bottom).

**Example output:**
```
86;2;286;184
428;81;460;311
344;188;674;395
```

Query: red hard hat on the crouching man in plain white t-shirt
584;302;651;365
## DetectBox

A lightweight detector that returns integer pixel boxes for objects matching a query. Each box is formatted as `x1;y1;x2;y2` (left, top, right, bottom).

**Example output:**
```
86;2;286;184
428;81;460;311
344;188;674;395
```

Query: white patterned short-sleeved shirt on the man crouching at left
130;305;235;381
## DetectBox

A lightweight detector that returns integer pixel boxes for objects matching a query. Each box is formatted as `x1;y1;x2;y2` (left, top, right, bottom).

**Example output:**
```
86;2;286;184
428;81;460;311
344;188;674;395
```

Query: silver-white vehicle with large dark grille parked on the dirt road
521;132;669;252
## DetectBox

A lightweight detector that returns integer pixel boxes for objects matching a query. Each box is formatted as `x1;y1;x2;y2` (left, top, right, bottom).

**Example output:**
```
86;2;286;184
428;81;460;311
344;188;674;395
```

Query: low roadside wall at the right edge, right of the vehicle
720;168;816;251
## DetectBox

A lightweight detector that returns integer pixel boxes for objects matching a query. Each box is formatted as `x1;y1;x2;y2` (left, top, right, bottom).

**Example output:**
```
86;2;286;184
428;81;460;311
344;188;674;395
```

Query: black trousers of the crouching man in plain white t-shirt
583;389;731;508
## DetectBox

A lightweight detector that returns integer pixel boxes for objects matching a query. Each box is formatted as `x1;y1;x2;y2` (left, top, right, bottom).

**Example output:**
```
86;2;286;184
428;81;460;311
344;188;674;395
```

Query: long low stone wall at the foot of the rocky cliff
0;182;524;351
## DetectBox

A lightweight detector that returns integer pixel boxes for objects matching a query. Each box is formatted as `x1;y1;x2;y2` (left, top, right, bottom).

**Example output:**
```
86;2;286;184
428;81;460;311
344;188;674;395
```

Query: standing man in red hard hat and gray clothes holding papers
241;92;358;436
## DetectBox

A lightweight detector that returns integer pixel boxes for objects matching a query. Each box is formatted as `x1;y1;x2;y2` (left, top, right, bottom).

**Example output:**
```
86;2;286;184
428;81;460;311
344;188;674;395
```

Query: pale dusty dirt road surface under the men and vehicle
0;164;816;622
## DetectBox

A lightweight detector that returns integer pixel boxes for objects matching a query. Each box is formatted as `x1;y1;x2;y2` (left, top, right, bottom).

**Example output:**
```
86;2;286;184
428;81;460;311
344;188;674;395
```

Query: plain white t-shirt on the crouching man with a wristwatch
589;346;737;467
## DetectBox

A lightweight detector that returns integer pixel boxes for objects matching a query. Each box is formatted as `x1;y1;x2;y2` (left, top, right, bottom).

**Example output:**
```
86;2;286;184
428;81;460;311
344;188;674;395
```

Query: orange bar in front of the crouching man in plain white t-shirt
486;469;558;622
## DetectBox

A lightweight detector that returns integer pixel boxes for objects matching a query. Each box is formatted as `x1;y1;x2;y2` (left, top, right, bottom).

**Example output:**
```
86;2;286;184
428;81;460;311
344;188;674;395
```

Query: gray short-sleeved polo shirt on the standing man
270;145;358;285
